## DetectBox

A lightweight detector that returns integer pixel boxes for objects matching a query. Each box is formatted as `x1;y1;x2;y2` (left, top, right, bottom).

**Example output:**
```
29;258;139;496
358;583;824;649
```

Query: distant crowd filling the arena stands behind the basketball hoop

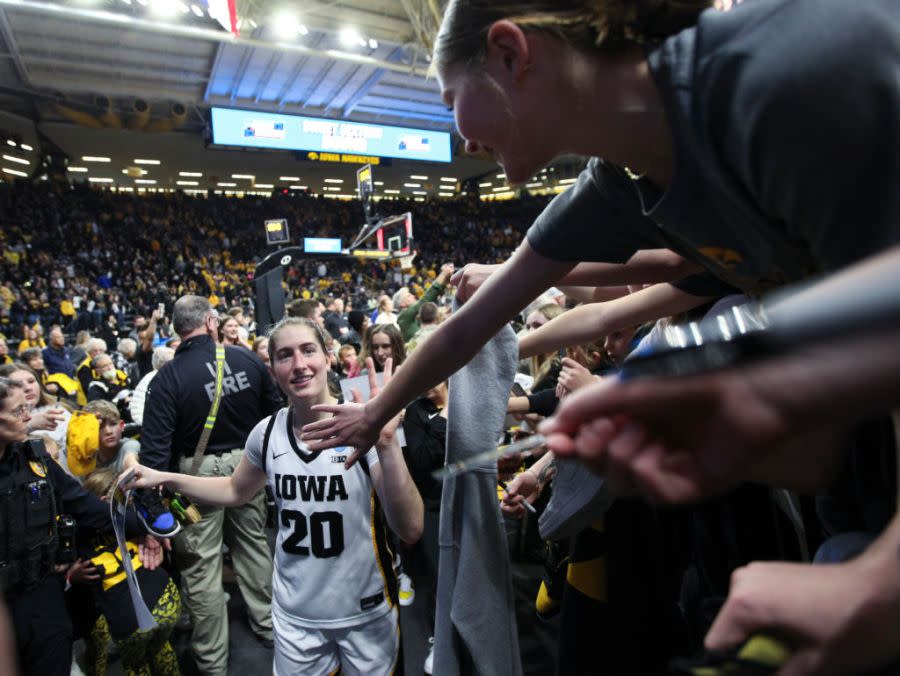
0;184;546;338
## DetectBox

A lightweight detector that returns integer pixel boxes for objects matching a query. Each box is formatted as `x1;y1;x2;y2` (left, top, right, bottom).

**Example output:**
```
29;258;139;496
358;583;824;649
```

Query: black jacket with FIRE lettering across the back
140;336;281;470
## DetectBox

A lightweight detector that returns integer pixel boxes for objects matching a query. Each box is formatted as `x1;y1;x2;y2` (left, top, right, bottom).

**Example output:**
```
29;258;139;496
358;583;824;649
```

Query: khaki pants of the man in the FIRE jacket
175;449;272;675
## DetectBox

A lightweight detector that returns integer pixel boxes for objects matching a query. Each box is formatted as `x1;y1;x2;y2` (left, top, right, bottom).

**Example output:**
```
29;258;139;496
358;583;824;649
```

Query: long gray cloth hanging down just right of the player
433;310;522;676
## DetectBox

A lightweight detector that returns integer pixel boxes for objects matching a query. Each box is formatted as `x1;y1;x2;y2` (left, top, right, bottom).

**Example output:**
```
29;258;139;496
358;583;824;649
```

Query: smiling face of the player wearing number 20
272;325;328;400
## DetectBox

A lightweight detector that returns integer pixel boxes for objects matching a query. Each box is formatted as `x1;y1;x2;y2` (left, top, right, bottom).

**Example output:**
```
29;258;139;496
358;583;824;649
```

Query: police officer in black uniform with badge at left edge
0;378;161;676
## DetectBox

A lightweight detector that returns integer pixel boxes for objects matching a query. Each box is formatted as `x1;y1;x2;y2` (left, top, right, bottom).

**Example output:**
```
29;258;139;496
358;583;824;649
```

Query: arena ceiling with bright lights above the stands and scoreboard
0;0;568;194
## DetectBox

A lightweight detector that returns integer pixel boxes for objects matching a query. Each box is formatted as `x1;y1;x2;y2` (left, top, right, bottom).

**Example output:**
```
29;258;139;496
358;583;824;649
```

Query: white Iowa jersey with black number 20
246;408;396;628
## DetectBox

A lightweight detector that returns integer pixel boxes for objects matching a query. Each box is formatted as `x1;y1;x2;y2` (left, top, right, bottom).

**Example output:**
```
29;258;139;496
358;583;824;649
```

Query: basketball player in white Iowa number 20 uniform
123;318;423;676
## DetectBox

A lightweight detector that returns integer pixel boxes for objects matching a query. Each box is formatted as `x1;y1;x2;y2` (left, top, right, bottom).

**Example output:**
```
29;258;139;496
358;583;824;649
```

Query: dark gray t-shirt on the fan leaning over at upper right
528;0;900;293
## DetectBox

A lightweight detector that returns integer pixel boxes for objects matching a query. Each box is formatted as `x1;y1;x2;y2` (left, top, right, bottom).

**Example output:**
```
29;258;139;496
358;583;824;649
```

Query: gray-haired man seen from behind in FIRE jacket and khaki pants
140;296;281;675
